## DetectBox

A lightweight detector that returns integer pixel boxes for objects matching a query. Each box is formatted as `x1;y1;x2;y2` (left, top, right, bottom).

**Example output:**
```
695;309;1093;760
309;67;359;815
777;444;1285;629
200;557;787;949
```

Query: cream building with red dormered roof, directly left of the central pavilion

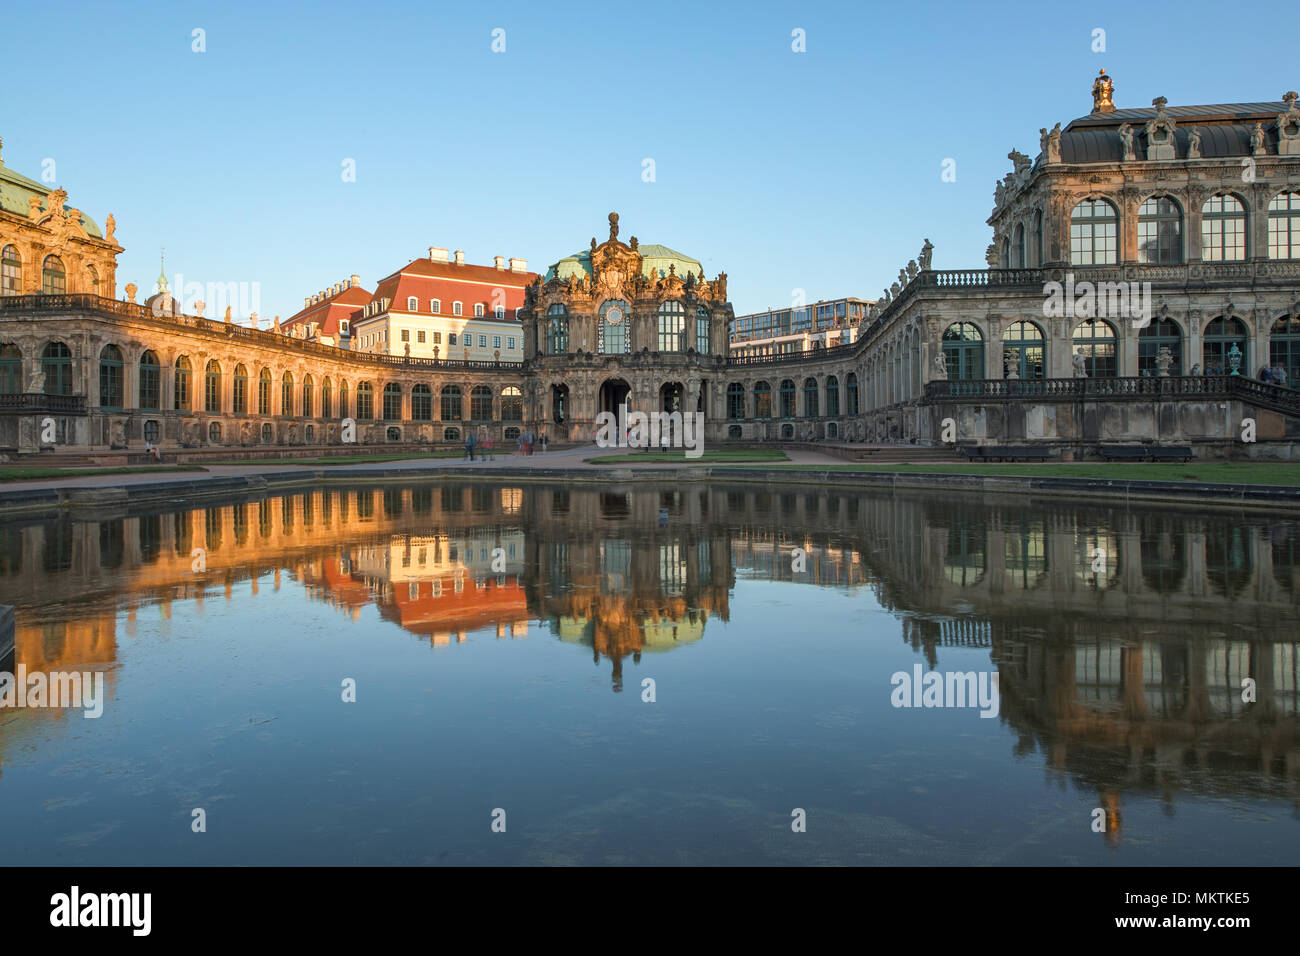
351;246;537;362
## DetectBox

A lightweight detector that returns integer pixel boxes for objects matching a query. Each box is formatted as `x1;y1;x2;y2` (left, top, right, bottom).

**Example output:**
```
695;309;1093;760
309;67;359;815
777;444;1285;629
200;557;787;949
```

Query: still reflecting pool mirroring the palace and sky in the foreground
0;483;1300;865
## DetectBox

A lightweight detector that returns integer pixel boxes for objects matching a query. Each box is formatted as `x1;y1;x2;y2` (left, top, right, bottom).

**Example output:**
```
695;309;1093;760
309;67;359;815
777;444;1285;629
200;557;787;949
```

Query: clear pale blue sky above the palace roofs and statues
0;1;1300;319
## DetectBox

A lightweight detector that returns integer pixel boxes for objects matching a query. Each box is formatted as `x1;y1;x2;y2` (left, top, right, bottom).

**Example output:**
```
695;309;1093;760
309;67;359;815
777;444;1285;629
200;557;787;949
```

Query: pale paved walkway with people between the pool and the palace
0;445;846;498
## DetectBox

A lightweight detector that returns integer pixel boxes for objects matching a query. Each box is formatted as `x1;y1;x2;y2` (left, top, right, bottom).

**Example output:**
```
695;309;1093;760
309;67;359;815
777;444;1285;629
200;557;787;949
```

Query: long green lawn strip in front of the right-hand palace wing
759;462;1300;485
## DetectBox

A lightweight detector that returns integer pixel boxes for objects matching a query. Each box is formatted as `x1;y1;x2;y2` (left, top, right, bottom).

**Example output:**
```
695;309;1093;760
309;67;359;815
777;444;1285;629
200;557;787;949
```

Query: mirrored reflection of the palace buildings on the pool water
0;485;1300;825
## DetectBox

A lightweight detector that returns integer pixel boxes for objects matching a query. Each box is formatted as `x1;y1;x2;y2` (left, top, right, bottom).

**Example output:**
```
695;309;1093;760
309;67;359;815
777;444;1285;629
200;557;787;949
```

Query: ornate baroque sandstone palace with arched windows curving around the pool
0;73;1300;458
